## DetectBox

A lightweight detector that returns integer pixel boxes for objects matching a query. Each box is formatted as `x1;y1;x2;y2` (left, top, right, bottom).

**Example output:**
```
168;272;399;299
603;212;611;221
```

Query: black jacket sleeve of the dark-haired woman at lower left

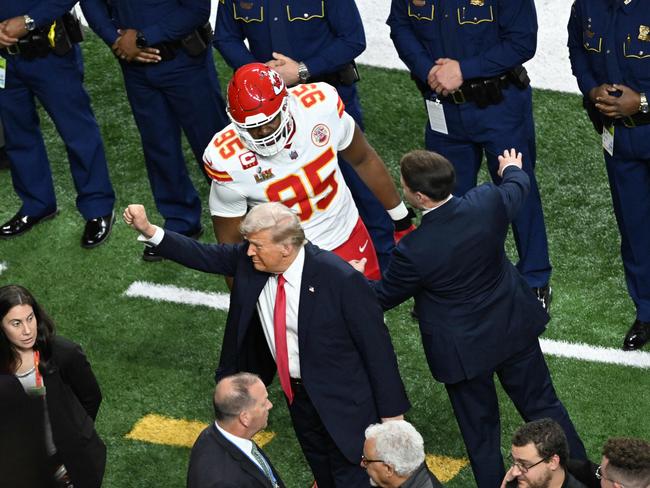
58;343;102;420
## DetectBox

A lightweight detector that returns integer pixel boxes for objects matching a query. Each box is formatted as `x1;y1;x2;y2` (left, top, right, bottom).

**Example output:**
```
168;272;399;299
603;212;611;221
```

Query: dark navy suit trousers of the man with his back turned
442;341;587;488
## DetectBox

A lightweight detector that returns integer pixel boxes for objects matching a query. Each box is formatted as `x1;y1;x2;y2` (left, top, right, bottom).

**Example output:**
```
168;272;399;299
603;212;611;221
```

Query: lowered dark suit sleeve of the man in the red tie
341;272;410;417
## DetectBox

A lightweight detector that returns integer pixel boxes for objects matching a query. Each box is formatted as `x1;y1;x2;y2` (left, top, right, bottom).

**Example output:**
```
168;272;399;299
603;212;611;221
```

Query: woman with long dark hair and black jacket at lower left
0;285;106;488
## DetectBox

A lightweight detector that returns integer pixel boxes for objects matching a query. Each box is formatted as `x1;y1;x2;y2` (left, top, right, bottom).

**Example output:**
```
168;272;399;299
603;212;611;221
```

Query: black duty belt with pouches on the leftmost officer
6;12;83;60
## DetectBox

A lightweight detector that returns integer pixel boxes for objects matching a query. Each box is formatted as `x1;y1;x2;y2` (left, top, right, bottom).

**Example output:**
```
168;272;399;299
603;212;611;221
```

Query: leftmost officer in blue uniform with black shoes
0;0;115;248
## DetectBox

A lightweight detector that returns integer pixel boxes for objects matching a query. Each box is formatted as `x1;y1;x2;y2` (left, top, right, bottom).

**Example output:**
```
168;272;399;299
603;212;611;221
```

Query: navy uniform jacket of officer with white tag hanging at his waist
387;0;537;88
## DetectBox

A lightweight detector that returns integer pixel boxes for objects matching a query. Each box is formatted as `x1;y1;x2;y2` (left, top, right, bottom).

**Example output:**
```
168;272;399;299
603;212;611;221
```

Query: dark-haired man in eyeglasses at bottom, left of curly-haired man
501;418;586;488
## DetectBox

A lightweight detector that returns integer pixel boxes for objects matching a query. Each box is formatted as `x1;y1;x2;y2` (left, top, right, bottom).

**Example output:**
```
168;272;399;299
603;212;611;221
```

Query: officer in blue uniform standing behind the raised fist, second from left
81;0;228;261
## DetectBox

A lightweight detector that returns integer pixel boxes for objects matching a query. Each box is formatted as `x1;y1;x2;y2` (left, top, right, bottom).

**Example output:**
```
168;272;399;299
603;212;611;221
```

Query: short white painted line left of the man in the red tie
124;281;230;310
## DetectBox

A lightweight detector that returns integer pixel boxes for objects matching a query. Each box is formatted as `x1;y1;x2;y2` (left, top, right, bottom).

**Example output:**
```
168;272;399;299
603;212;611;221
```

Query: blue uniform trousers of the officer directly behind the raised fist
120;49;227;234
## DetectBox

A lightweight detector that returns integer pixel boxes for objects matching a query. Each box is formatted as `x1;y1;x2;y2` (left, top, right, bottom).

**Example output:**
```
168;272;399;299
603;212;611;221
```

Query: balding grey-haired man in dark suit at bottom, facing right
187;373;284;488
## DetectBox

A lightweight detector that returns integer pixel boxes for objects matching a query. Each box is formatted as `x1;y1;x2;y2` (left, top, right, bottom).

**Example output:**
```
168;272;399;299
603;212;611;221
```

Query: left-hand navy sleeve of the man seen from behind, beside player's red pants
370;243;421;310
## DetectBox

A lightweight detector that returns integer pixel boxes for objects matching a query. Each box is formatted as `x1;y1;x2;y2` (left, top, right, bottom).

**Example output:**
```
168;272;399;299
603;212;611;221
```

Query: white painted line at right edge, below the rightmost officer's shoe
539;339;650;369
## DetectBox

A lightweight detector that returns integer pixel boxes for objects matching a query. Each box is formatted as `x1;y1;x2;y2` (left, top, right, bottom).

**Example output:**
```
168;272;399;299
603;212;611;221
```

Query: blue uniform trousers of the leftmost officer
0;45;115;220
